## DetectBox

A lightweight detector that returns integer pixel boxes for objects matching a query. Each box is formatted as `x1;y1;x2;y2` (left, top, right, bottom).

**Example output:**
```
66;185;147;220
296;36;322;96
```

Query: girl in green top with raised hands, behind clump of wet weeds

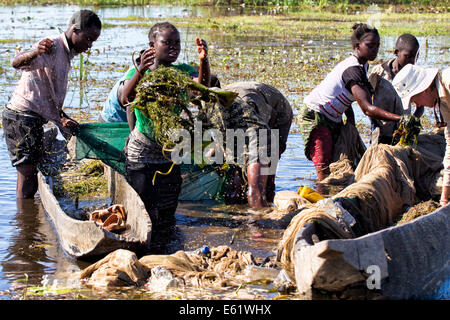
118;22;210;224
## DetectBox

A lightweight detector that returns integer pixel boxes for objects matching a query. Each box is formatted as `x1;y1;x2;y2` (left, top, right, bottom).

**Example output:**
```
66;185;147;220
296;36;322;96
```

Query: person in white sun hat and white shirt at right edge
392;64;450;206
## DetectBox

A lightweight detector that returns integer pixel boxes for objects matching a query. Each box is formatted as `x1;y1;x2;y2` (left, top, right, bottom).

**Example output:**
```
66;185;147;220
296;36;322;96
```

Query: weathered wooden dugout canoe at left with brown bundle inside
38;168;152;259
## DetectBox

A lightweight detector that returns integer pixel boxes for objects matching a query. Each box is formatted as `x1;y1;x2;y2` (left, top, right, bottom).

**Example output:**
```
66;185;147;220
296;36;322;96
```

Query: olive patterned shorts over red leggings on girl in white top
298;105;342;160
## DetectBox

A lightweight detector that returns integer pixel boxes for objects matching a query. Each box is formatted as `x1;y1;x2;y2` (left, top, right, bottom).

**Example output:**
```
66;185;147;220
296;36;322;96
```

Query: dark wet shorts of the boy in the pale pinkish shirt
2;108;46;167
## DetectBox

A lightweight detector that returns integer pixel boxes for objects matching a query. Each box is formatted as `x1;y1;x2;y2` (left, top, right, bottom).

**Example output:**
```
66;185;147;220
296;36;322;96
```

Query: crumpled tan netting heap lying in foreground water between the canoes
80;246;255;288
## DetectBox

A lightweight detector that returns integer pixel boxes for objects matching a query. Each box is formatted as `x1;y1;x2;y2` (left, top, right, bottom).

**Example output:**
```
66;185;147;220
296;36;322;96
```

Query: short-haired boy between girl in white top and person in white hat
369;33;424;144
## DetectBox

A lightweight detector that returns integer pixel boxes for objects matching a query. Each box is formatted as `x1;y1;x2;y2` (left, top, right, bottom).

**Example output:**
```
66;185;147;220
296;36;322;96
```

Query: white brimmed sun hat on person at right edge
392;64;439;110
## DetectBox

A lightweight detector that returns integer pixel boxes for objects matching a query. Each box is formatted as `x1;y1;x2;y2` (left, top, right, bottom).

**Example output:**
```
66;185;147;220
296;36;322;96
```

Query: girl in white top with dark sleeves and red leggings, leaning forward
298;23;401;181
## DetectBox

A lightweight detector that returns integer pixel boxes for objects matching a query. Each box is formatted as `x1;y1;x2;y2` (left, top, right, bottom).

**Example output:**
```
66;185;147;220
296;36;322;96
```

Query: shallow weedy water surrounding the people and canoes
0;6;450;299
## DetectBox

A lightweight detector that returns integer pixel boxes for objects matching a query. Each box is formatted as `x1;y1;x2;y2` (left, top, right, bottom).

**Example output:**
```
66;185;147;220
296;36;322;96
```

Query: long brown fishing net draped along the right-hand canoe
278;144;442;271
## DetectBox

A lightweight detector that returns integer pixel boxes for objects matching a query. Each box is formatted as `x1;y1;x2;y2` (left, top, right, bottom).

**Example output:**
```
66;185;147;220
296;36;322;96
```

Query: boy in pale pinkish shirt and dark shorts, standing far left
2;10;101;199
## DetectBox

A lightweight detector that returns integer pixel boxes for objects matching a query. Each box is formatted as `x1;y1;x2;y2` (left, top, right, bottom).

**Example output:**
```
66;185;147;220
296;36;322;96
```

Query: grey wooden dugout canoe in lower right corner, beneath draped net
294;206;450;300
